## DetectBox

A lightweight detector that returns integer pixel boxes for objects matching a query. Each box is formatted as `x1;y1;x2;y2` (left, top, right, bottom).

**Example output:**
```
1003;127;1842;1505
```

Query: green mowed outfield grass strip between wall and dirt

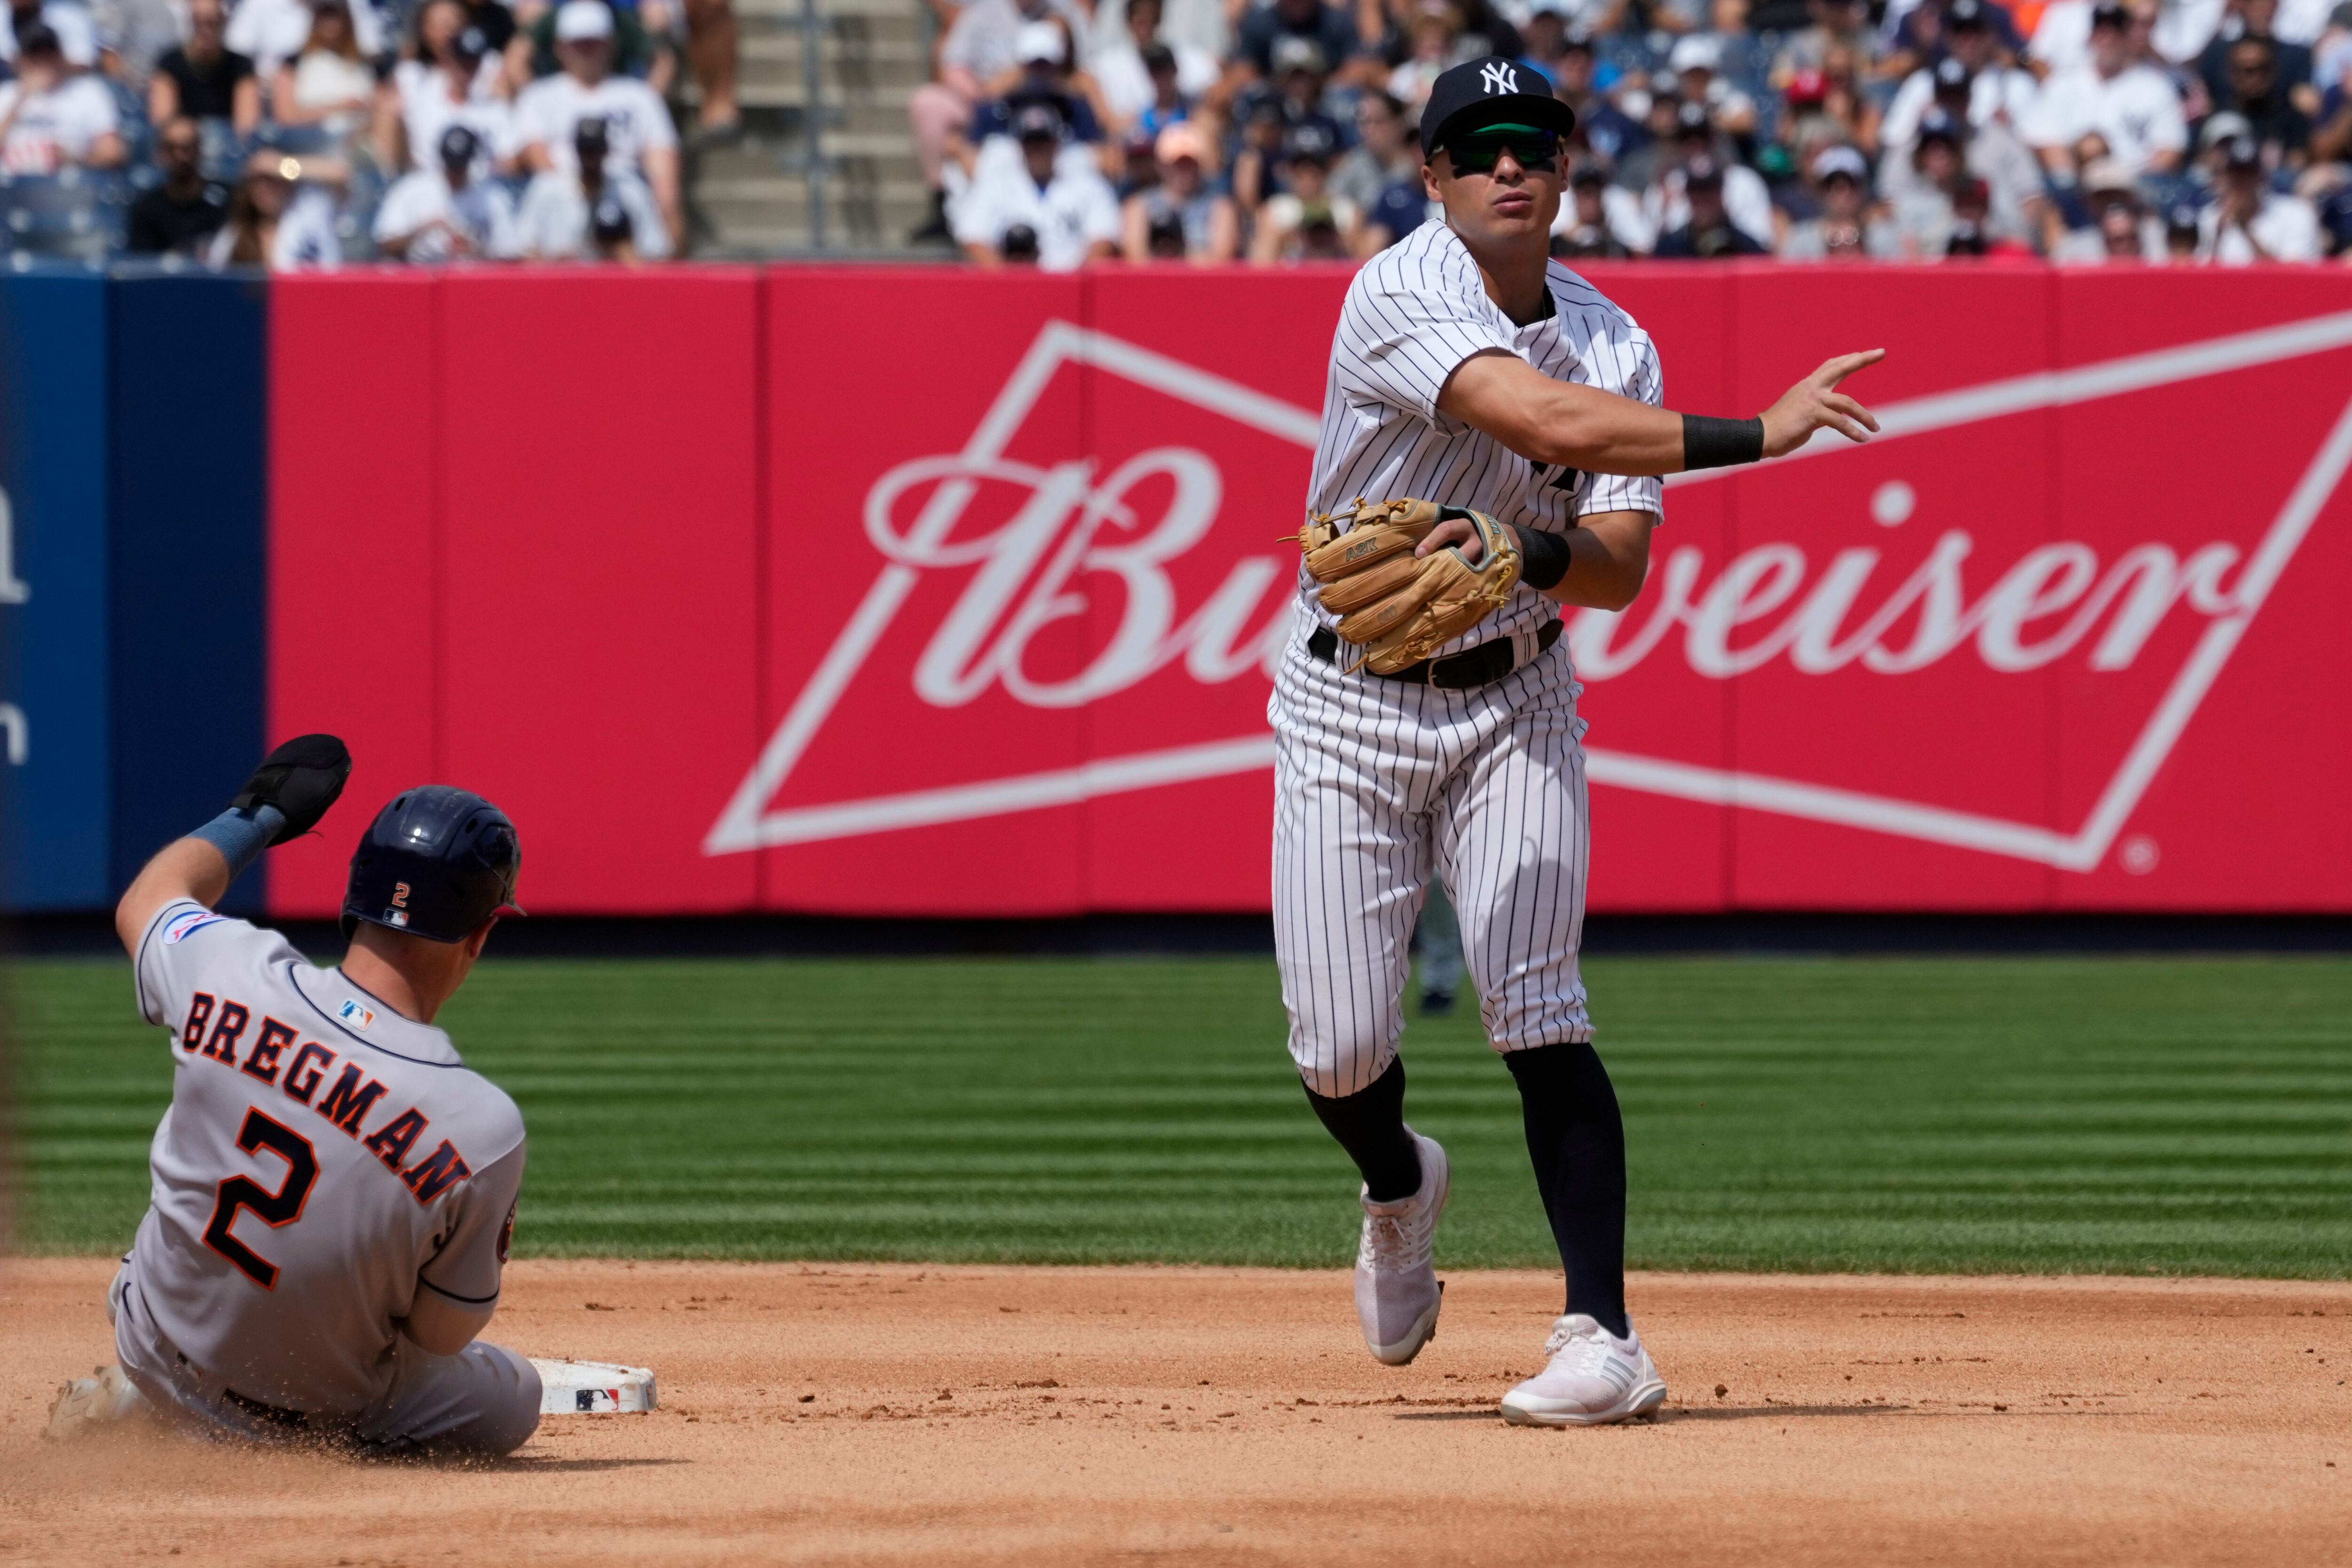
9;959;2352;1279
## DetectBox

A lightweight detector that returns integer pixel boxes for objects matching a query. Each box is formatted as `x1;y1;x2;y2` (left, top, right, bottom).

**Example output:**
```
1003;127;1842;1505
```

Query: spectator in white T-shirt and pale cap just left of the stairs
515;0;687;254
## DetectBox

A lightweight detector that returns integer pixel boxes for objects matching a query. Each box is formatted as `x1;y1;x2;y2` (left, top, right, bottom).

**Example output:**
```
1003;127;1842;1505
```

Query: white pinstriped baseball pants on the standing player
1268;628;1592;1098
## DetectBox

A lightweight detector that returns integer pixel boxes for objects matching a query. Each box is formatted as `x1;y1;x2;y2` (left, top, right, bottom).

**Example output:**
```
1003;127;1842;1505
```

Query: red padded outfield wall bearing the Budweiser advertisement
270;266;2352;915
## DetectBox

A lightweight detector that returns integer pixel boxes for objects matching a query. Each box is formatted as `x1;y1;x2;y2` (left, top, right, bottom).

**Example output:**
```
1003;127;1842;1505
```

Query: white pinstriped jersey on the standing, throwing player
1298;223;1663;653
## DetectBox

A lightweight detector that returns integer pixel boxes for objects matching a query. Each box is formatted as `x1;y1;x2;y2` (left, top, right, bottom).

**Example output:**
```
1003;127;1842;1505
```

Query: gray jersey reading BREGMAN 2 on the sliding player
132;900;522;1415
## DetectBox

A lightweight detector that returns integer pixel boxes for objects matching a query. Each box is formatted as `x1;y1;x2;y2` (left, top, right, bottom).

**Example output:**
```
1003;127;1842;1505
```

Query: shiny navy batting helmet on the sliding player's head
343;785;522;943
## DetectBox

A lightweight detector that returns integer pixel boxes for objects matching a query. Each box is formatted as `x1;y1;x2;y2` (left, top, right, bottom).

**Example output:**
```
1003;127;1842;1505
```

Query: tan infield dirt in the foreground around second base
0;1260;2352;1568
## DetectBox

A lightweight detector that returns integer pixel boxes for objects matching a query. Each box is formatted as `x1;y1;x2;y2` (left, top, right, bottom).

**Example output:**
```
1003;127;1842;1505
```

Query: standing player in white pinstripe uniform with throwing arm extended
1268;59;1879;1425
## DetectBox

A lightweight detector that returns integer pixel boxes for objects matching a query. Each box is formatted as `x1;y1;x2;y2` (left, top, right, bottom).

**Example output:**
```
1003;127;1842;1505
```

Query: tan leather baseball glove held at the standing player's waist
1298;498;1519;675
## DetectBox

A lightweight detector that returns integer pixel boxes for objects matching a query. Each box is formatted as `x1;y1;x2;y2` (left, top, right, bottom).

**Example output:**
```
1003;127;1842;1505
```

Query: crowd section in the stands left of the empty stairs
0;0;739;268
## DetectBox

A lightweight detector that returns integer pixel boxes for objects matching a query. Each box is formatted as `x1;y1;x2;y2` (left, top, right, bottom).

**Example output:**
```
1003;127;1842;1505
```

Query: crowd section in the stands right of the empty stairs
910;0;2352;268
